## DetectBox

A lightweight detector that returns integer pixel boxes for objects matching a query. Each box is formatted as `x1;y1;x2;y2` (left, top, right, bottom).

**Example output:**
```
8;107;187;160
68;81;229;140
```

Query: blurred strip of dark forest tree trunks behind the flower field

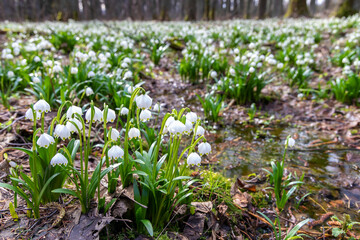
0;0;360;21
